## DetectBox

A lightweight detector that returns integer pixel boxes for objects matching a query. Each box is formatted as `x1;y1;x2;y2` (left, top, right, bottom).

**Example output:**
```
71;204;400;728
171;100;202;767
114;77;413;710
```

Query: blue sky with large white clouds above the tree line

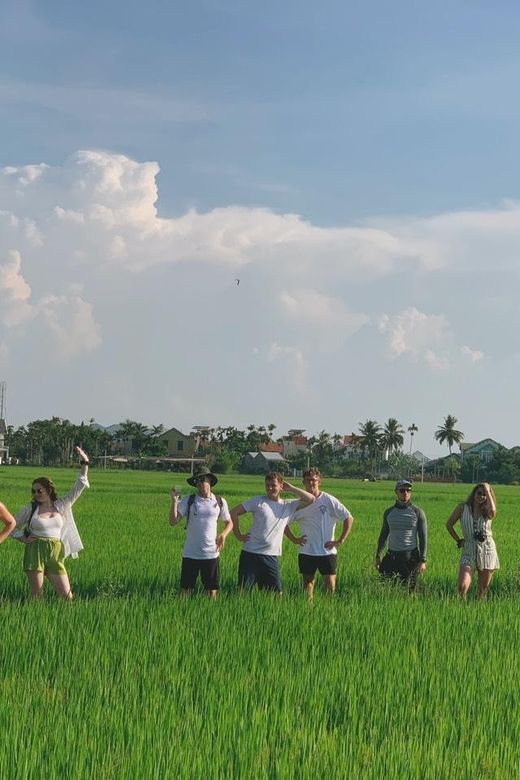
0;0;520;454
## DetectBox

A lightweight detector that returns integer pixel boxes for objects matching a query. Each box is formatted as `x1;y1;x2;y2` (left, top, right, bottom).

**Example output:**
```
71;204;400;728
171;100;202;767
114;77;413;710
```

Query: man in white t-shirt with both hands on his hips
285;468;354;601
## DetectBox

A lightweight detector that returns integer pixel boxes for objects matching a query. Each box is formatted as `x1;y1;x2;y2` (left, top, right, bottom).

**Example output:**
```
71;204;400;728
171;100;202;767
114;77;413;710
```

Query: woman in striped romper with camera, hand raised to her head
446;482;500;598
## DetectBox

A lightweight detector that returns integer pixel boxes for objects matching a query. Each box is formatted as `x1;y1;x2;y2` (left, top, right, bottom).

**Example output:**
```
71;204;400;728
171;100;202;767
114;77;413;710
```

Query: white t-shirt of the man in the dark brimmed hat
177;493;231;560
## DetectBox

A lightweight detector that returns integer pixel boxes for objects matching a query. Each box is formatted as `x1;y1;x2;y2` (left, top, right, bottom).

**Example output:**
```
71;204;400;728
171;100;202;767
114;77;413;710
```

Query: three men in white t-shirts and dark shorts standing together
170;469;354;598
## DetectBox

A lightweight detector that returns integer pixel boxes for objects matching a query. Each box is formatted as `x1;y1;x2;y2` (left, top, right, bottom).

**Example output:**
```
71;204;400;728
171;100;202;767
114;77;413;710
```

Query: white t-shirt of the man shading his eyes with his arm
242;496;300;555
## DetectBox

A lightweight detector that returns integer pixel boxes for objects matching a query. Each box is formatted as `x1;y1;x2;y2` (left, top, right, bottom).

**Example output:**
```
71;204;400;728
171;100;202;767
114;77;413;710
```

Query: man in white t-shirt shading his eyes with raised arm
231;471;314;593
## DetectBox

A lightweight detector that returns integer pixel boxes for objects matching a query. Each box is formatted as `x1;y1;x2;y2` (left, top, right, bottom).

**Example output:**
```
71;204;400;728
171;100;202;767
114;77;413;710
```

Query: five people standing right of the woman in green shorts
170;468;499;599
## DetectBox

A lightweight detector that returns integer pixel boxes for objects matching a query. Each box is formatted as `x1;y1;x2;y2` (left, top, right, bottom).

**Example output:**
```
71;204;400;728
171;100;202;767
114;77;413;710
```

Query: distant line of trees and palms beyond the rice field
5;415;520;484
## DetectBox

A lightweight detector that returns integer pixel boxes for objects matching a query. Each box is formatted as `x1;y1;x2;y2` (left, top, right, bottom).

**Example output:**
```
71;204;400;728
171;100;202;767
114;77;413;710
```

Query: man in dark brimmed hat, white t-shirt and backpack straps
170;471;233;599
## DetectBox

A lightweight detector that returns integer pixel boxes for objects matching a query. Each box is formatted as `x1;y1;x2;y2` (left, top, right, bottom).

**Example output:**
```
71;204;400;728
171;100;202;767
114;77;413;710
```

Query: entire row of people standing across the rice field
0;454;499;600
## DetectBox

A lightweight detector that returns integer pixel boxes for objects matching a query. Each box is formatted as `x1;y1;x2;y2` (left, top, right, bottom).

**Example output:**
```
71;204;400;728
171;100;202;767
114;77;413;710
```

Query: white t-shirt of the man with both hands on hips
293;493;350;555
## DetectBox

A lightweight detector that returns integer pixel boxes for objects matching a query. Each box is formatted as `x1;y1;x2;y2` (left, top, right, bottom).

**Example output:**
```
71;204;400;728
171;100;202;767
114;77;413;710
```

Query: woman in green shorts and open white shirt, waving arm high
12;447;89;601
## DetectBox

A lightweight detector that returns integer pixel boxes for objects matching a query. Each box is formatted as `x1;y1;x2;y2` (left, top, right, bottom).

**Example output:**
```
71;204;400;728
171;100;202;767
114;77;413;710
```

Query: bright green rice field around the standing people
0;467;520;780
